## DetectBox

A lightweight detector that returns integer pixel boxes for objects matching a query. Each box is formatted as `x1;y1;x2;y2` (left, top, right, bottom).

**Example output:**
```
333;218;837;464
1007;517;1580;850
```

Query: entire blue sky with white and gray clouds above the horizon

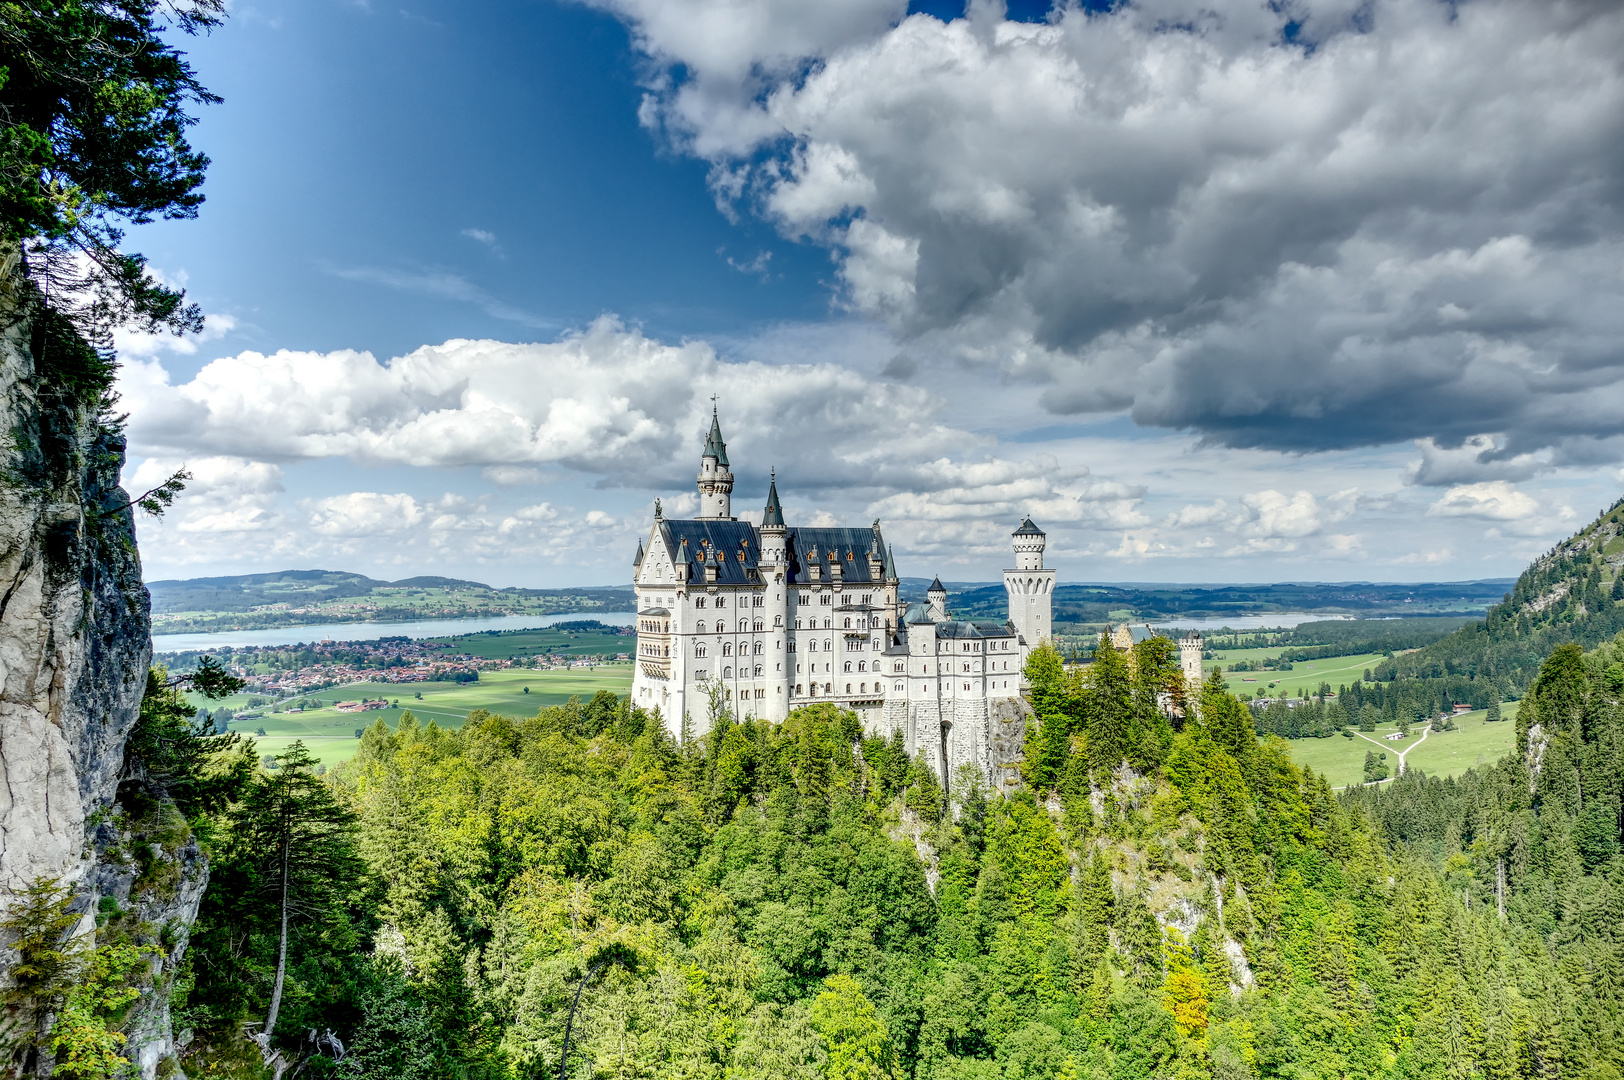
122;0;1624;586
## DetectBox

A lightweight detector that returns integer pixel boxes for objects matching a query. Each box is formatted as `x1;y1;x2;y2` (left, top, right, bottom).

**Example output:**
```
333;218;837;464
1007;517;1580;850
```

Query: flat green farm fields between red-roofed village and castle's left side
211;664;632;765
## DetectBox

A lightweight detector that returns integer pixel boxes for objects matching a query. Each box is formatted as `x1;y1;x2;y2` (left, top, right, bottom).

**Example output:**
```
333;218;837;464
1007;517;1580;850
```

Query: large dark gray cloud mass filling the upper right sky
606;0;1624;454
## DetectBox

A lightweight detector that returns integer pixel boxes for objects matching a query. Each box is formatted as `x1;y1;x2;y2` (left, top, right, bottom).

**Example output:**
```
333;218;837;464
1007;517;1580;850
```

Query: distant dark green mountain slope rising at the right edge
1374;500;1624;708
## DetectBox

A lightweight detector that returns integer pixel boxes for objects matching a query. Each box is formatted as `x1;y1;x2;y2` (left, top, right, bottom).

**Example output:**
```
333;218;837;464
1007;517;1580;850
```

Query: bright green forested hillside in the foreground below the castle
117;638;1624;1080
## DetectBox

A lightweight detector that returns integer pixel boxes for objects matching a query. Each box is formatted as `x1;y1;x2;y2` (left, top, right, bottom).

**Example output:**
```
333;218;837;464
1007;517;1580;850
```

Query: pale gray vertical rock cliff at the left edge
0;278;206;1077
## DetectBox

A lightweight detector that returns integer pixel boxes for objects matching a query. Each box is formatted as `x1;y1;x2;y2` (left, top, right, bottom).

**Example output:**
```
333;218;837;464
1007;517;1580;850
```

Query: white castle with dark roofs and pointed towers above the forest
632;409;1054;784
